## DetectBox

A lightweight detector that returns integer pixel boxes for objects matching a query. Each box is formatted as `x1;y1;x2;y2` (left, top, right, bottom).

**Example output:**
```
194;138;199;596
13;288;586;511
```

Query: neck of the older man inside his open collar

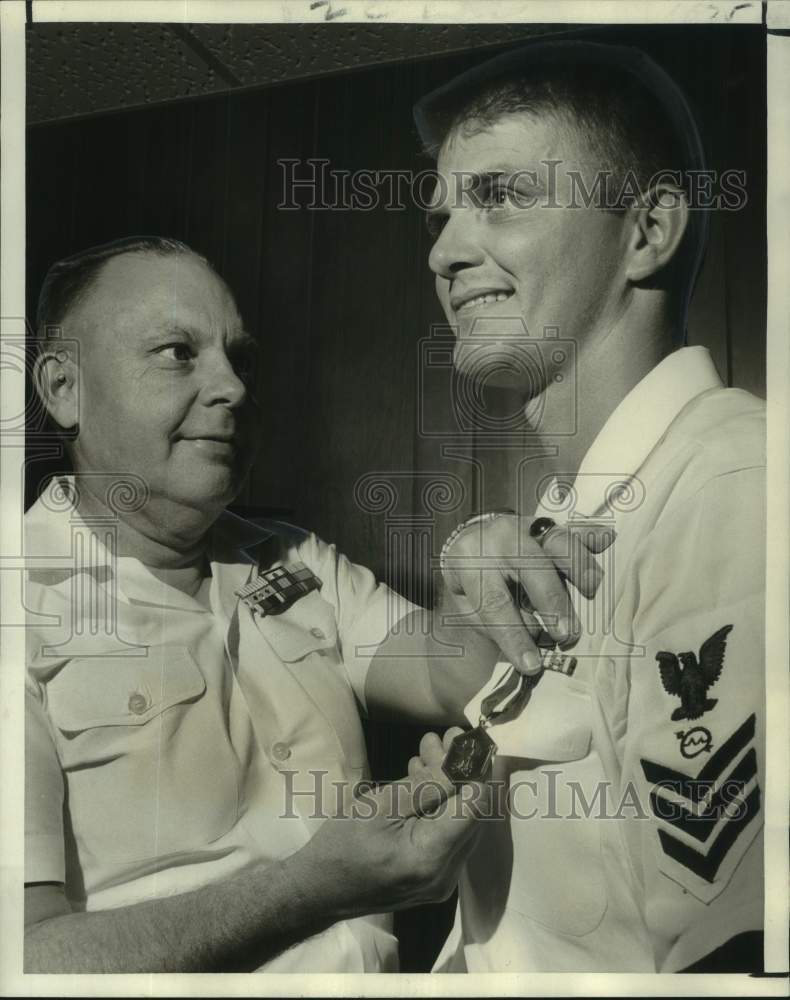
75;473;216;570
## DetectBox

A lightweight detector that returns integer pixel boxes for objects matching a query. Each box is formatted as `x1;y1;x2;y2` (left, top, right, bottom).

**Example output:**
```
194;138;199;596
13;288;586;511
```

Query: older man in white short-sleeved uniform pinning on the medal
25;238;508;972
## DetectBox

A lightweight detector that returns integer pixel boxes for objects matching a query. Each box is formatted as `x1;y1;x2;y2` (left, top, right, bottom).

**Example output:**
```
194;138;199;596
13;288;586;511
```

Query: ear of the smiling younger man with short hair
626;184;689;282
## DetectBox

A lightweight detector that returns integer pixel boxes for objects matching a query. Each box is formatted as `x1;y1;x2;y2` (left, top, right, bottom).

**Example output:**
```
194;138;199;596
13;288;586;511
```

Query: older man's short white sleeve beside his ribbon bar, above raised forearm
300;535;416;711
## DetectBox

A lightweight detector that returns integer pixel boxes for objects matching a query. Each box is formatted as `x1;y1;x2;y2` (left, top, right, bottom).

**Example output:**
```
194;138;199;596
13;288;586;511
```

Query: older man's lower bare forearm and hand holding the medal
25;729;490;972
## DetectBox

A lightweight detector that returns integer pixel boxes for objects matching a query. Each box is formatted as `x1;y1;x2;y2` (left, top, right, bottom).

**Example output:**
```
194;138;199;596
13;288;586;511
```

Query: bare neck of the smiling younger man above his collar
541;308;673;484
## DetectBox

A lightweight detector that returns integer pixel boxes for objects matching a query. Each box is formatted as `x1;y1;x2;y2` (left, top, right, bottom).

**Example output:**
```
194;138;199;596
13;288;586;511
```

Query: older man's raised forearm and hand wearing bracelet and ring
365;514;614;726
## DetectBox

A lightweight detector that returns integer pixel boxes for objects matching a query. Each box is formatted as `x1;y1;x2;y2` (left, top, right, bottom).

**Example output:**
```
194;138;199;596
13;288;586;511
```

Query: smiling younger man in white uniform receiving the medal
416;41;765;971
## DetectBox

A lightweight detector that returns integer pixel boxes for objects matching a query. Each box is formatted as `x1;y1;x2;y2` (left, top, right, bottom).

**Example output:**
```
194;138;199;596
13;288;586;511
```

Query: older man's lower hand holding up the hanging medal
304;729;490;916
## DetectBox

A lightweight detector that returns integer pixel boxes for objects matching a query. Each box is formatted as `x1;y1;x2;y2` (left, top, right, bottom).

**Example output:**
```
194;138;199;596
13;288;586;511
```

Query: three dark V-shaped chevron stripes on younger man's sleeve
641;715;760;883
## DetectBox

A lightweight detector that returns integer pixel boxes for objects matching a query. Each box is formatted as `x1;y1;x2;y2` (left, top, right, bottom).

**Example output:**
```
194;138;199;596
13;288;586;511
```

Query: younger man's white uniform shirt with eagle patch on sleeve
436;347;765;972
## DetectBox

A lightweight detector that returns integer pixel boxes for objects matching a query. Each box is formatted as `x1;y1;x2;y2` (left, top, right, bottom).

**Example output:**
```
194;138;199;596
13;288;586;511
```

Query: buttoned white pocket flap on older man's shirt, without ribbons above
47;645;206;732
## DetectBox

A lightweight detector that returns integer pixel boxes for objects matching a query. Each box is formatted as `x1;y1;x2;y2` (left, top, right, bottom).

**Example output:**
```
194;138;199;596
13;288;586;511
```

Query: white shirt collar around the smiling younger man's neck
539;346;722;519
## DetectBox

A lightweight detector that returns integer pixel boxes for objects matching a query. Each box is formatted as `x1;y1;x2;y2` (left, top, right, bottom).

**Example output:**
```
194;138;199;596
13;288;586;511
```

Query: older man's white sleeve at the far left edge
25;685;66;883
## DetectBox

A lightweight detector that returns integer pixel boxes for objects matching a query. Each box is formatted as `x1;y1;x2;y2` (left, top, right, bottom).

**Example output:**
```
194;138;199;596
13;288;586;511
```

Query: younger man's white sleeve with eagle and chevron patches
626;468;765;972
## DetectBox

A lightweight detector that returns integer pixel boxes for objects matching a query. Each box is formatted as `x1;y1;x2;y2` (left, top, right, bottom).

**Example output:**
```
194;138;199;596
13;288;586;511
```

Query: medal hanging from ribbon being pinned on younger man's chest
442;649;576;784
